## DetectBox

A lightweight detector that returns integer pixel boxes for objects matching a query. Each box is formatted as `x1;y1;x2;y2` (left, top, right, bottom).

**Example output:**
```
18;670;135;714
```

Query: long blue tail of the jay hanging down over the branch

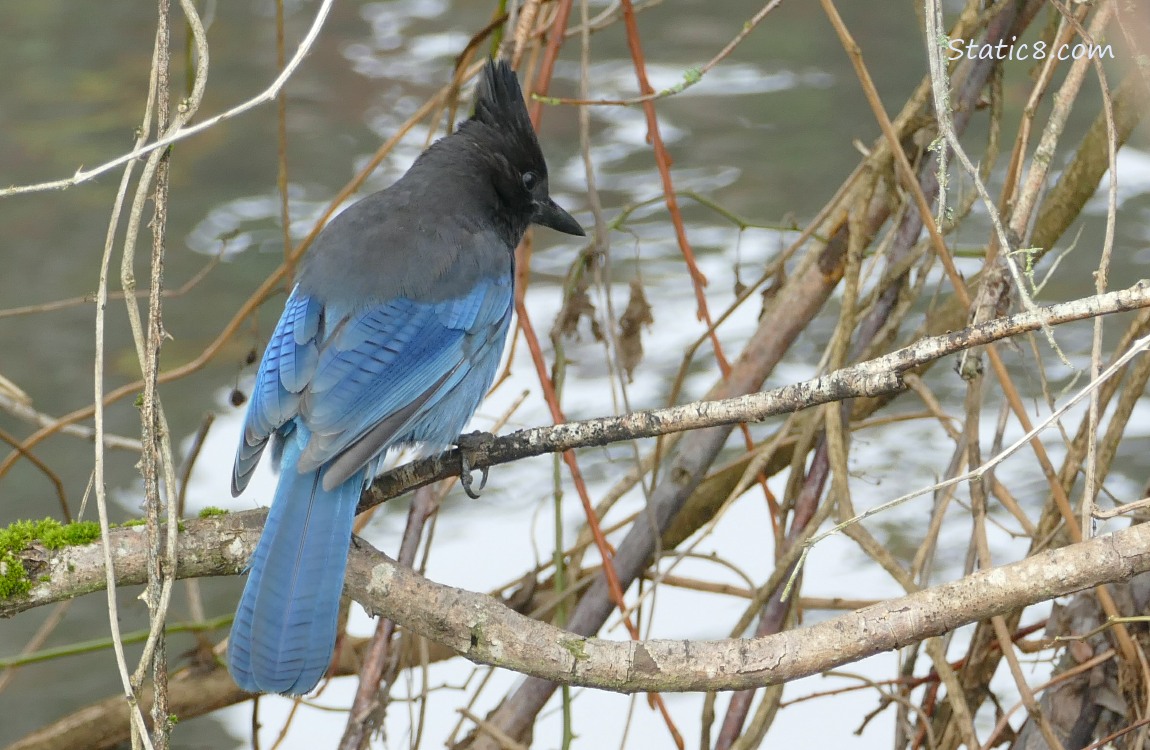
228;438;365;695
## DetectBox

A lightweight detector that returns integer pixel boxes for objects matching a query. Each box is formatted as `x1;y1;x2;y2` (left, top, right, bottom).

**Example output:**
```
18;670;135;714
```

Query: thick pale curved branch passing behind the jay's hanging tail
0;512;1150;692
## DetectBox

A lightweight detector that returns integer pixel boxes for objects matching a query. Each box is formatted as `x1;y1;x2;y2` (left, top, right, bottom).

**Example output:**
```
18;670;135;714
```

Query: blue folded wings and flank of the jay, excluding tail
232;276;513;491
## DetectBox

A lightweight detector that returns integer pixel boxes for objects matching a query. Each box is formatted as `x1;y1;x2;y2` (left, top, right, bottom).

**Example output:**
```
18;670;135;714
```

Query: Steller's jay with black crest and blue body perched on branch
228;62;583;695
